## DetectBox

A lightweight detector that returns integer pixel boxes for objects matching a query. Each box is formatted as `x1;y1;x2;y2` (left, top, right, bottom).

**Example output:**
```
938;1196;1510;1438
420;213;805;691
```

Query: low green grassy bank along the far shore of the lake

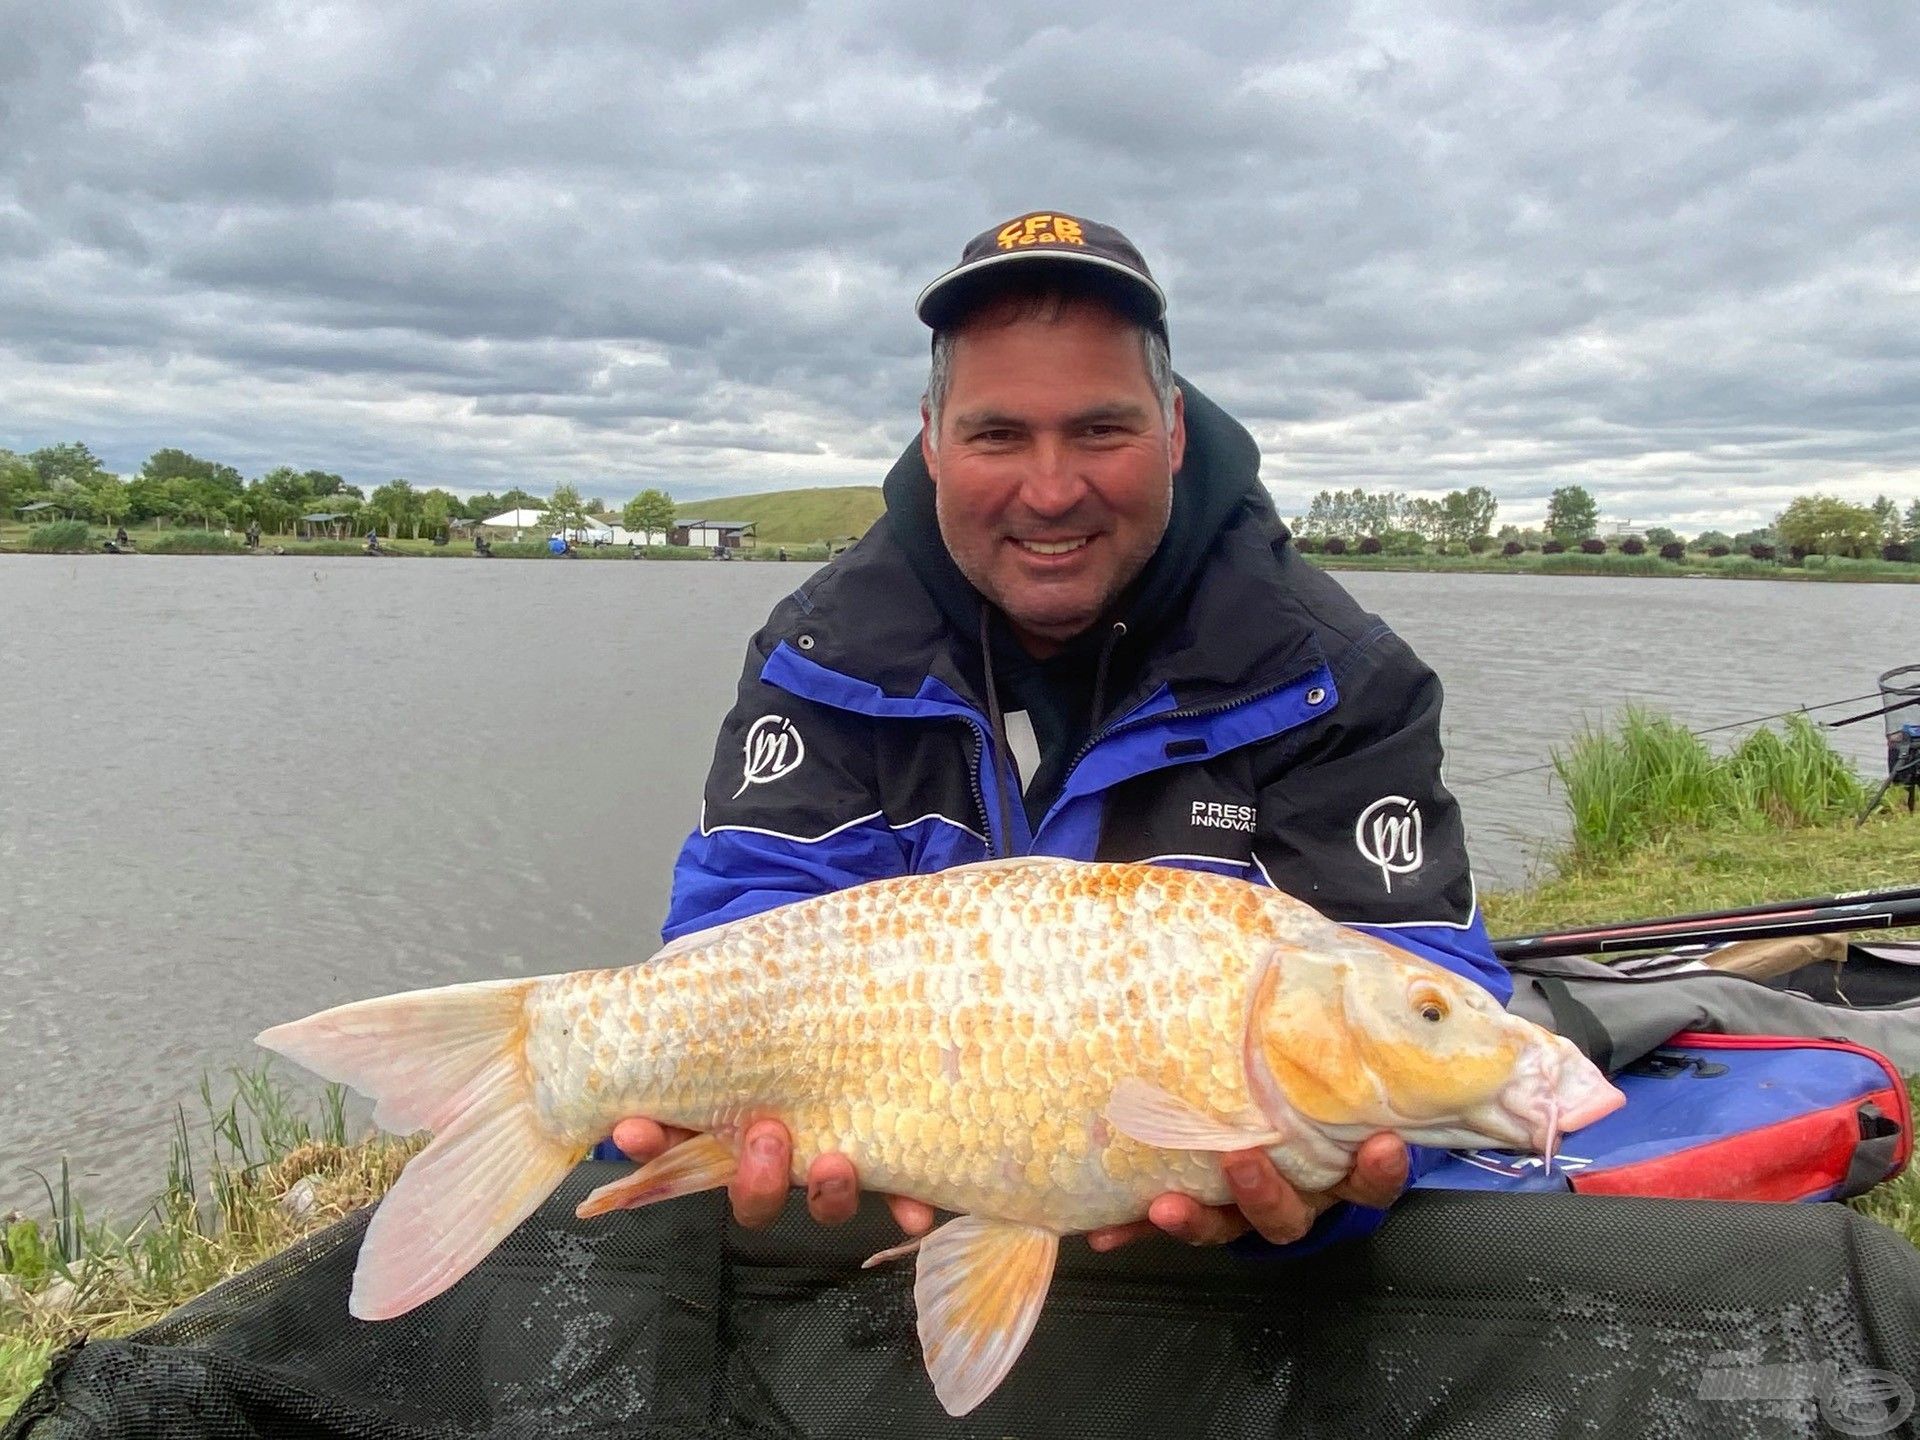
0;520;1920;586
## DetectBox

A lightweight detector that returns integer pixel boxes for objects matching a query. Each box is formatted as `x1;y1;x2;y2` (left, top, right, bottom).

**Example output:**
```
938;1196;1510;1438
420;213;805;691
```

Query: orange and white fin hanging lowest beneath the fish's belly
914;1215;1060;1415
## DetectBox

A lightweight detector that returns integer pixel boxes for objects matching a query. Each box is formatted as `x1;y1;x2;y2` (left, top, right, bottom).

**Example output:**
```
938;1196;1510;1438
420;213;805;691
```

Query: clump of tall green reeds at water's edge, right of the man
1553;707;1866;868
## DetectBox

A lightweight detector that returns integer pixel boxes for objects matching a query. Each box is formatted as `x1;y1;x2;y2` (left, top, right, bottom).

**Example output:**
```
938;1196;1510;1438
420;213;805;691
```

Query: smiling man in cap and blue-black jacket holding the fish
614;213;1507;1248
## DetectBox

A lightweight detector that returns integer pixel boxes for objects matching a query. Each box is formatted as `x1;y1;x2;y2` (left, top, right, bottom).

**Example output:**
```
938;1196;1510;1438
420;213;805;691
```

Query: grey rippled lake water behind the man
0;557;1896;1213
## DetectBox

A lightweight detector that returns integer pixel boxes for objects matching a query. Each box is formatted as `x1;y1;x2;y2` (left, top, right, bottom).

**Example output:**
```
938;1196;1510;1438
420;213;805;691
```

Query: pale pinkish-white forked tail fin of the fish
257;979;588;1319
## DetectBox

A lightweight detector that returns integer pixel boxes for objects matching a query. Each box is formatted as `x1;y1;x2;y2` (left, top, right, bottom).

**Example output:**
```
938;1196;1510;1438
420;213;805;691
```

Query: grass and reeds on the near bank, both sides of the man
0;710;1920;1421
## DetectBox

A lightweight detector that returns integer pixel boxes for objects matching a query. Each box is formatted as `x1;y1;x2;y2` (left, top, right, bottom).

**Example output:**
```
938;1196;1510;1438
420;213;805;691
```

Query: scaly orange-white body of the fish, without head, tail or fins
526;866;1267;1229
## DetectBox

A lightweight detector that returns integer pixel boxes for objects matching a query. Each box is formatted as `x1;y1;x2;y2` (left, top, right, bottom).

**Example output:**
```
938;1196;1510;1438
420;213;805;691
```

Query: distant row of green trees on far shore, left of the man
0;442;674;540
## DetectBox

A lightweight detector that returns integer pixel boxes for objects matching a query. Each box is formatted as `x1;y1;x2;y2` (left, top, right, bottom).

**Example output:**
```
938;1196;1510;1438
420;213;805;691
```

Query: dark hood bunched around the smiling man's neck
883;376;1273;664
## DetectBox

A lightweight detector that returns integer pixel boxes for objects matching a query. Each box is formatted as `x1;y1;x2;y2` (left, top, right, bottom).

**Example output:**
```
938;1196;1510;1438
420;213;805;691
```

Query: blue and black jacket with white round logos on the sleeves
666;386;1511;1244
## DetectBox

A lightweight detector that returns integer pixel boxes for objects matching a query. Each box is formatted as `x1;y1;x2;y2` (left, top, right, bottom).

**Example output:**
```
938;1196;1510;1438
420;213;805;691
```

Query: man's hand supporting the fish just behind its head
1087;1135;1407;1250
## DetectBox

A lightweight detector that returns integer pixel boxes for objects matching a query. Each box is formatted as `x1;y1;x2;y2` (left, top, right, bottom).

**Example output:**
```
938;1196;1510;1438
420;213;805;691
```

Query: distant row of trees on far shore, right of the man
1292;486;1920;561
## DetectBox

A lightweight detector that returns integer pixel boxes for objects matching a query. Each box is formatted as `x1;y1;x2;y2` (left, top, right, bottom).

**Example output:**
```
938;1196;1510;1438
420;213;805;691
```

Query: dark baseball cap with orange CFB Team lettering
914;209;1167;334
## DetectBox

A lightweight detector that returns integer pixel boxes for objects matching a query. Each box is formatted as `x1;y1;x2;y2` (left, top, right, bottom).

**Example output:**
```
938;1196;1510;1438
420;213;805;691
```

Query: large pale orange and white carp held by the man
259;856;1622;1415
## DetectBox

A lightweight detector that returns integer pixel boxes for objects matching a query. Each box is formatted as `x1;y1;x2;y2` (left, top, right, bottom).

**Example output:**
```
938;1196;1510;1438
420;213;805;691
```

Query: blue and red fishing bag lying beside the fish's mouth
1417;1031;1912;1202
